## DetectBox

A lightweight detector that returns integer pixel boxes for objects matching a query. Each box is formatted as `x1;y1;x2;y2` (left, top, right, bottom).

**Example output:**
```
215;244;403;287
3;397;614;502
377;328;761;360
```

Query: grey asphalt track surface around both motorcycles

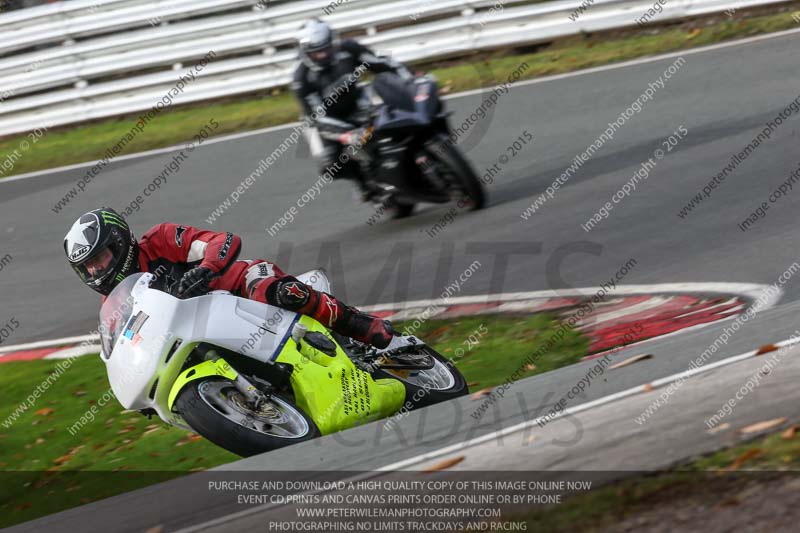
0;30;800;531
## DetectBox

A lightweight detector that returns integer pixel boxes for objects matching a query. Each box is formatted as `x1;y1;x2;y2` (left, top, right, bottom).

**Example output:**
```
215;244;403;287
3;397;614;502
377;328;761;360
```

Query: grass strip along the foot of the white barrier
0;4;797;177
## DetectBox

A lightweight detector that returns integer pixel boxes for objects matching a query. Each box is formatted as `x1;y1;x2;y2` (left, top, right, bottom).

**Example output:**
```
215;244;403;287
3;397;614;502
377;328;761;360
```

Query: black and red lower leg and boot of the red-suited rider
267;276;395;349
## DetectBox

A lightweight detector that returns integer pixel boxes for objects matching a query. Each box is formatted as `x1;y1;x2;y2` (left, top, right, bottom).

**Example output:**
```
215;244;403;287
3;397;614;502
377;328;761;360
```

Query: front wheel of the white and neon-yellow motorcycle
175;377;319;457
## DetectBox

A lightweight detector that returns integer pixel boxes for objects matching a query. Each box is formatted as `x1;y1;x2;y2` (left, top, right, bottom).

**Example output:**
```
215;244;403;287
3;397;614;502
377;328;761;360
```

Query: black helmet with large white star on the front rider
64;207;139;295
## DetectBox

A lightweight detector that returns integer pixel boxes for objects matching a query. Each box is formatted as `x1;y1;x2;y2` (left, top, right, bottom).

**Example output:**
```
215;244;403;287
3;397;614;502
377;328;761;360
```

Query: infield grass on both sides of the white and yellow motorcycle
0;315;588;527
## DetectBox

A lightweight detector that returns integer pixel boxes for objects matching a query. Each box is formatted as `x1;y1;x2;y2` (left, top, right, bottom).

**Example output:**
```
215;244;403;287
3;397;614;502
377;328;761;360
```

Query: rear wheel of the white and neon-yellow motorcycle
373;346;469;408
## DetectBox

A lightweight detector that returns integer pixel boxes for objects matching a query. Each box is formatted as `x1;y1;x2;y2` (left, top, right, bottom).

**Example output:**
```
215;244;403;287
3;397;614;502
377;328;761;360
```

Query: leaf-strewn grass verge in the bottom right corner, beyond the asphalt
509;422;800;532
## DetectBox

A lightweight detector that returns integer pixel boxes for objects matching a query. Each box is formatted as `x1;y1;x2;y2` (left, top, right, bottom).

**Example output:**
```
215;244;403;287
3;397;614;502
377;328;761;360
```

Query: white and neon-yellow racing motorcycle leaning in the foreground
100;270;467;456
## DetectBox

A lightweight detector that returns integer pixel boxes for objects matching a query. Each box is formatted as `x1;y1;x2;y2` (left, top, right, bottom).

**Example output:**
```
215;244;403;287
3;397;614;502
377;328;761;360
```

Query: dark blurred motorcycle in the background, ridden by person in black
319;73;486;218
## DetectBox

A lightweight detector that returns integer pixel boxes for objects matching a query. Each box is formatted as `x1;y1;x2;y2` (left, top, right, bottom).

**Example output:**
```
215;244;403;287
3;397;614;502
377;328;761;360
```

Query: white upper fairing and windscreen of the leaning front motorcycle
100;270;330;423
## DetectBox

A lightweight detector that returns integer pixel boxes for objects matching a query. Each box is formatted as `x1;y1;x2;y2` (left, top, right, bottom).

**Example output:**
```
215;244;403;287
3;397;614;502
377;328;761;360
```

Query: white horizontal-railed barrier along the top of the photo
0;0;788;136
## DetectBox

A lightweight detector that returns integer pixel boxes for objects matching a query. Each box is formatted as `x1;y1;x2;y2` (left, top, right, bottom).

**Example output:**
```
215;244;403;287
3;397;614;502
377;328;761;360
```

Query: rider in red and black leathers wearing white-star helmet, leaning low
64;208;394;348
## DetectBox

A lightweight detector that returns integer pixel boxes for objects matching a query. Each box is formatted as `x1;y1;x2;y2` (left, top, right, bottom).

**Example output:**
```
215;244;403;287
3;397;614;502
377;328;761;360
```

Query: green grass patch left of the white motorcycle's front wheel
0;356;238;527
